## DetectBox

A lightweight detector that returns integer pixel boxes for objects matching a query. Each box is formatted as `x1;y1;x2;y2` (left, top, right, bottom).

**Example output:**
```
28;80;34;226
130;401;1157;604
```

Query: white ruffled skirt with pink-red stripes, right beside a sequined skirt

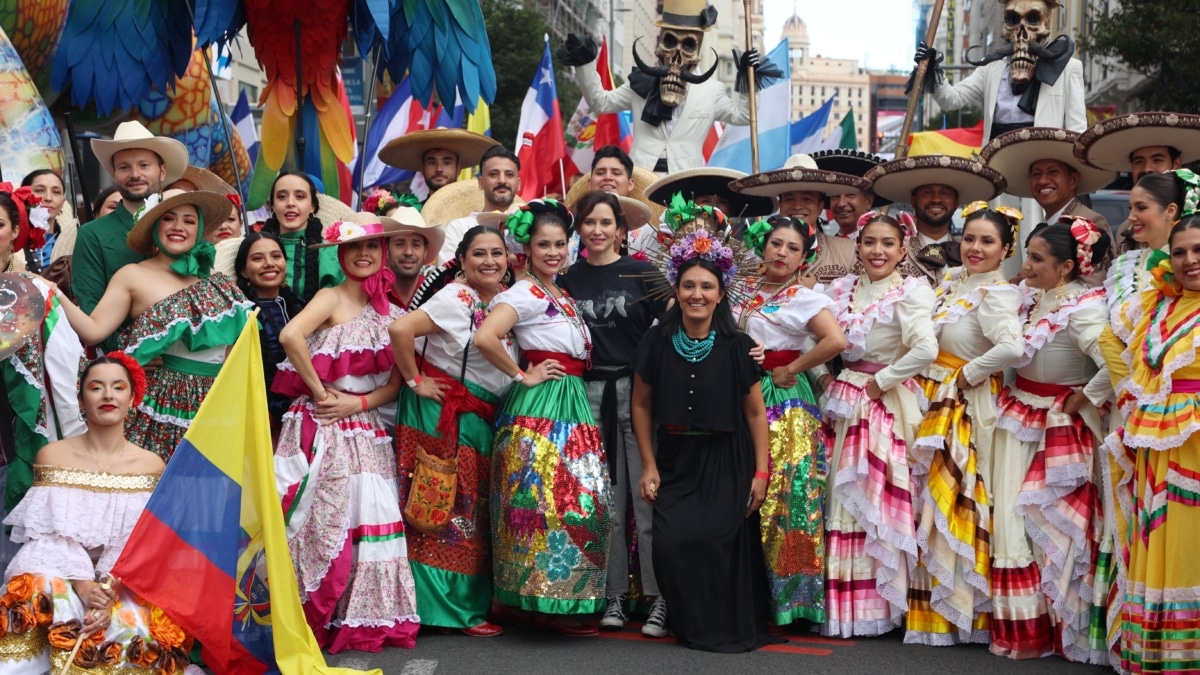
822;369;922;638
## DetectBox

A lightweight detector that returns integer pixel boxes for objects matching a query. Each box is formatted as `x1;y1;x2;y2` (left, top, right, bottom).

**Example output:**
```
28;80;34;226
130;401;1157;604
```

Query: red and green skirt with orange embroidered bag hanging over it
396;382;498;628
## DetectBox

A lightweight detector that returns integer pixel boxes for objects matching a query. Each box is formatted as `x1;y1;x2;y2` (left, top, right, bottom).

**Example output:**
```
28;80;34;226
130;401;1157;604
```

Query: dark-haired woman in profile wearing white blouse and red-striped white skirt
991;216;1112;663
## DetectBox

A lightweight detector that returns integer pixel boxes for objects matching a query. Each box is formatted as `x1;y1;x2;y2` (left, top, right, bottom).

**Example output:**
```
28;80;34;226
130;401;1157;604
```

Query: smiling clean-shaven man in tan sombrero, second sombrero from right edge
979;127;1117;287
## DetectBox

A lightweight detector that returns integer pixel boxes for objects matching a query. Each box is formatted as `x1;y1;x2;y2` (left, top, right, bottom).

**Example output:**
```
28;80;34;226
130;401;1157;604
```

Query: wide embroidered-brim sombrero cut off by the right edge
1074;112;1200;172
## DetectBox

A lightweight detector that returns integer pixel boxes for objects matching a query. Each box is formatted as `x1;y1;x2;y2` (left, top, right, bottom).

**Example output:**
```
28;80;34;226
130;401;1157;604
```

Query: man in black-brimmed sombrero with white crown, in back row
730;155;871;288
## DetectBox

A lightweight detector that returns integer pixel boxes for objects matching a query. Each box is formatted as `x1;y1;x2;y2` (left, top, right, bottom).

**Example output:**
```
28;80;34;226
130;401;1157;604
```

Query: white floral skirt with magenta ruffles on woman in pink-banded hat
275;396;420;653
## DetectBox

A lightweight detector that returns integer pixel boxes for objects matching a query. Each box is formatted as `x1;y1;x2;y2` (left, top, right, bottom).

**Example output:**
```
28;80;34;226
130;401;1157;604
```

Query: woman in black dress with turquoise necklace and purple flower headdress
632;235;772;653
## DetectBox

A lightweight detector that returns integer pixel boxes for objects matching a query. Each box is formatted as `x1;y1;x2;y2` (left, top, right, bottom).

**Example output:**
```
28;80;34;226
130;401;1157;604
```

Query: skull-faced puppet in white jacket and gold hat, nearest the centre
557;0;782;175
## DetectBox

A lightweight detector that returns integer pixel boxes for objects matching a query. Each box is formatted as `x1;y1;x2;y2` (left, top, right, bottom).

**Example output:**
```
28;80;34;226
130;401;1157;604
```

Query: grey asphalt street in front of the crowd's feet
328;623;1112;675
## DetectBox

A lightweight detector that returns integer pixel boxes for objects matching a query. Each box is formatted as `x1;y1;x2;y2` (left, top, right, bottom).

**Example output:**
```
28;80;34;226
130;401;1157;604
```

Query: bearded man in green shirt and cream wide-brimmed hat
71;121;187;352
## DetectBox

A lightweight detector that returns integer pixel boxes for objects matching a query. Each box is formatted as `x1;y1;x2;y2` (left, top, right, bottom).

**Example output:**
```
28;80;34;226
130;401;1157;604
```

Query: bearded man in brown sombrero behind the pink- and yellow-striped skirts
864;155;1007;282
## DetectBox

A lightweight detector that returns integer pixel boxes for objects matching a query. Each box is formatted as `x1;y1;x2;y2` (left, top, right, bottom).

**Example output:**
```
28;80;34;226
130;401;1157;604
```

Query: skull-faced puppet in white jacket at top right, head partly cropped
910;0;1087;141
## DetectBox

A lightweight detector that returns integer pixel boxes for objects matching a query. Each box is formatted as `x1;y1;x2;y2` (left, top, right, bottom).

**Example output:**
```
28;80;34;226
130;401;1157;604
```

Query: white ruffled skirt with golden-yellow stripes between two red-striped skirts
905;353;998;646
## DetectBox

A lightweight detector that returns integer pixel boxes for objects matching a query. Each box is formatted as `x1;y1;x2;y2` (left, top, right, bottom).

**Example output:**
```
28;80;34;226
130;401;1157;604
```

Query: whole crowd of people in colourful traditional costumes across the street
0;102;1200;671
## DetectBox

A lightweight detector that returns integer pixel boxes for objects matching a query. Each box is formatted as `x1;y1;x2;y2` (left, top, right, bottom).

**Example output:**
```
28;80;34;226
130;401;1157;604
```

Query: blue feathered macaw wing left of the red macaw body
50;0;192;115
